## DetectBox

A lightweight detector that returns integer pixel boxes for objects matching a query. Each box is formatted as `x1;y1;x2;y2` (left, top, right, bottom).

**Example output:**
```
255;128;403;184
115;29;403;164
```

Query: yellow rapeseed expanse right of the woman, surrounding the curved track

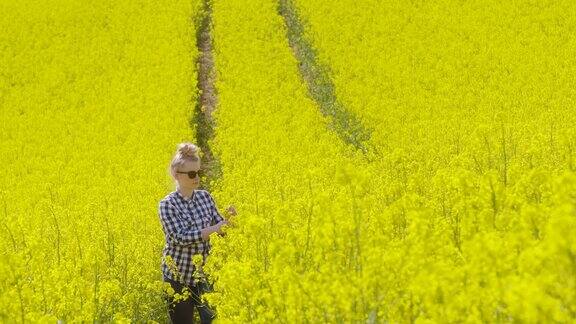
206;0;576;323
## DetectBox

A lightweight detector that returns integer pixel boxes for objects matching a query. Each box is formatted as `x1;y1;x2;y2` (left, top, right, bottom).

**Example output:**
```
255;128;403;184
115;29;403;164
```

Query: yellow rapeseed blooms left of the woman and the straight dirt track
0;0;201;323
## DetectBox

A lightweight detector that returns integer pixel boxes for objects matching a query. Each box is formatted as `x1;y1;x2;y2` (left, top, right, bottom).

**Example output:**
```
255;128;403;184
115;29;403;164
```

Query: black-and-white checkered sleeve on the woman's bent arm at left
158;201;203;245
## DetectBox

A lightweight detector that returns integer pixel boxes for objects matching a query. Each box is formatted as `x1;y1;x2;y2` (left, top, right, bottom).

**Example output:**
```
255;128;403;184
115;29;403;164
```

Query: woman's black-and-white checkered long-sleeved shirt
158;190;224;285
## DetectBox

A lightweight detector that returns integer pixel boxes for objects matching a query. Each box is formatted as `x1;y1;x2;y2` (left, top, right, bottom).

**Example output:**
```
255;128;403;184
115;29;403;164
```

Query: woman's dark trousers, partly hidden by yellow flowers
164;278;216;324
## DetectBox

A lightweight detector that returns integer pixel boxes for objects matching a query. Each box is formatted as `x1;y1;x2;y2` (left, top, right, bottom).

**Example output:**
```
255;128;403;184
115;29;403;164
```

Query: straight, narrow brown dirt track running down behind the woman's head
191;0;221;190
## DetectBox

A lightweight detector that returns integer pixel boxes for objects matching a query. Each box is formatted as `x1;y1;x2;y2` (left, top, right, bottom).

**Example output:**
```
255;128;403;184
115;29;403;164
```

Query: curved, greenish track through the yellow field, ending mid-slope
278;0;375;154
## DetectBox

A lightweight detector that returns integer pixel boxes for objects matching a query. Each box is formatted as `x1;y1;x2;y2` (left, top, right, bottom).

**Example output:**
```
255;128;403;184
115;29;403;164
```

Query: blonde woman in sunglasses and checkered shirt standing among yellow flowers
159;143;236;324
